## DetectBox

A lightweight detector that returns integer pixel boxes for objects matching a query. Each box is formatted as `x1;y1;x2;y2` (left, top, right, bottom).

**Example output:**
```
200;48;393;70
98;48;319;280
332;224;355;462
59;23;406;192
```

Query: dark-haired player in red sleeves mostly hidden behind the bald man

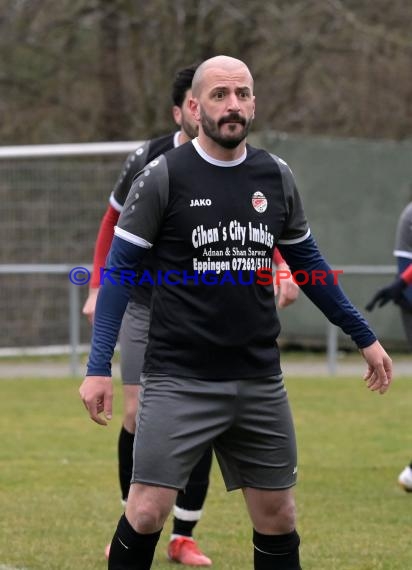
83;65;297;566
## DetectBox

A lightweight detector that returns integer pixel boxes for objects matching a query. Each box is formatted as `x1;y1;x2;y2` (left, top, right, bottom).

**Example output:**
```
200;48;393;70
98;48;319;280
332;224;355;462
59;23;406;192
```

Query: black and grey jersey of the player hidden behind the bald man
110;131;180;307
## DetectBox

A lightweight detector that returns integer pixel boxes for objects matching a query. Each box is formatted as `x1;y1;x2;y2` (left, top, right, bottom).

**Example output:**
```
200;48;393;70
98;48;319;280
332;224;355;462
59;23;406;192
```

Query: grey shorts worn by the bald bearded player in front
132;374;297;491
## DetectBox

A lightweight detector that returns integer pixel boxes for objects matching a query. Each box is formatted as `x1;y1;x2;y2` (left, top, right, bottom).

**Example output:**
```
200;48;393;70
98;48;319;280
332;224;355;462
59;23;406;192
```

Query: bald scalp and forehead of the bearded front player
192;55;253;97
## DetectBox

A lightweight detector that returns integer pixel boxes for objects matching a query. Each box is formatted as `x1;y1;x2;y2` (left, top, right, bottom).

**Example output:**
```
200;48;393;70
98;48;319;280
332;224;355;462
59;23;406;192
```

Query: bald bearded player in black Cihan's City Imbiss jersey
80;56;392;570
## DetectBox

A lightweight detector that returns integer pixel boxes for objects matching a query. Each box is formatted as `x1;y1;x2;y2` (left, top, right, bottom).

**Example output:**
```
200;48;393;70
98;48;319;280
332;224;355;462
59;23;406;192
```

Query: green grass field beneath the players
0;372;412;570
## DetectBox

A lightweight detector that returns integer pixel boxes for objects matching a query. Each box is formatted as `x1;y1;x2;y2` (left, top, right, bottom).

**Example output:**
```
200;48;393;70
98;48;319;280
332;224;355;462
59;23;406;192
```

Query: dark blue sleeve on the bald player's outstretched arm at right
278;236;376;348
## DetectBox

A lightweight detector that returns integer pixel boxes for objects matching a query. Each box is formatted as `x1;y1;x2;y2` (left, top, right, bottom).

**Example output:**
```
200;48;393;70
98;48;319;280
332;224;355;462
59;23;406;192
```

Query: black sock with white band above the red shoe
172;447;212;536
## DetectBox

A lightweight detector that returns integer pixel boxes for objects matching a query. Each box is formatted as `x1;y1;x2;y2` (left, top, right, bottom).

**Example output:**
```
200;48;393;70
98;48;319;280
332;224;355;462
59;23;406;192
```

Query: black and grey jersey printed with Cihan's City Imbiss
115;139;309;379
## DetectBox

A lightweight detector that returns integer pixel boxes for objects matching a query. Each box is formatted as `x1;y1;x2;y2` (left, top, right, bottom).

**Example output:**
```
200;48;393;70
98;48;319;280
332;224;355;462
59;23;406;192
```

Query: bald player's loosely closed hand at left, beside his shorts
79;376;113;426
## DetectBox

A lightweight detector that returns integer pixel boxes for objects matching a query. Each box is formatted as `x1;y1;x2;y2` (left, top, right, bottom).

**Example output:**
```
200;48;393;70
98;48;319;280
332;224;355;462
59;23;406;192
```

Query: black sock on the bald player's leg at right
253;529;301;570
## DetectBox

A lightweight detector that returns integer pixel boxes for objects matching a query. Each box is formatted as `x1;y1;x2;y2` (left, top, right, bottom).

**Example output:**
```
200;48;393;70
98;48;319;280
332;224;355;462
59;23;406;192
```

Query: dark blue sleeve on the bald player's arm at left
86;236;148;376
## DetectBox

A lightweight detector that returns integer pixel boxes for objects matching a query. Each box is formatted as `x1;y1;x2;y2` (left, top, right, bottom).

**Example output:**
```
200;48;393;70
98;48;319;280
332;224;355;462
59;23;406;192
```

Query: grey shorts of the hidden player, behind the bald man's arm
119;301;150;384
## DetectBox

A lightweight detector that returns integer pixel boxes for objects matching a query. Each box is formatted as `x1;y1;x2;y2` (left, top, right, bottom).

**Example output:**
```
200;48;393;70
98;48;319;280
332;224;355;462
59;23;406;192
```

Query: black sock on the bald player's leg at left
108;515;161;570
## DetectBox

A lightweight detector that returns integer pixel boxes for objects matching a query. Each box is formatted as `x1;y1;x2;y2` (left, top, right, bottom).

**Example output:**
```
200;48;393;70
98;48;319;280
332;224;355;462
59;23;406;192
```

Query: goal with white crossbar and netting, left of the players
0;141;142;358
